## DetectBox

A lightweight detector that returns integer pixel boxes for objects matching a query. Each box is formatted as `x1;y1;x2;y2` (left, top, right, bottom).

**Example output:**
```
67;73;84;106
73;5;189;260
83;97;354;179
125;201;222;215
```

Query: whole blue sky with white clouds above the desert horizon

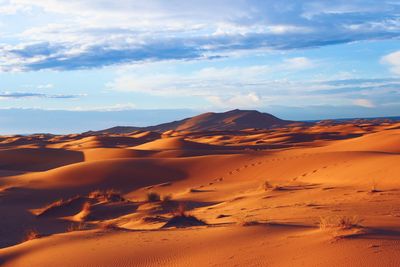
0;0;400;133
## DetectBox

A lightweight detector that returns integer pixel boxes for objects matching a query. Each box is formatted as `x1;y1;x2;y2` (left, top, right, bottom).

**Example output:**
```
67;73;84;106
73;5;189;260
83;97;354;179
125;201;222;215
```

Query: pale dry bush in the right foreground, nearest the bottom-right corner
319;216;363;230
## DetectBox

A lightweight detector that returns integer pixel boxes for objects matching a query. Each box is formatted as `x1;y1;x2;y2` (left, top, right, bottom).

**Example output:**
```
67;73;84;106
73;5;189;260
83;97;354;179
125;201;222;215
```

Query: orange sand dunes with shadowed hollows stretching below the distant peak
0;110;400;267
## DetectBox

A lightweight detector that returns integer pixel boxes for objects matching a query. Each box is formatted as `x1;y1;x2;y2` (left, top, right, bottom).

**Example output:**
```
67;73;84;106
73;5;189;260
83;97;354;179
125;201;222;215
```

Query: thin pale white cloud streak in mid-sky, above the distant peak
107;57;318;97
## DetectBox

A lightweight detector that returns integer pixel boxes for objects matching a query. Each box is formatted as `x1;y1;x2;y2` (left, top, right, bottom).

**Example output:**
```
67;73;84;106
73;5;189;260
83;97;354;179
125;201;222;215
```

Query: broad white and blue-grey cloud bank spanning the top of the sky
0;0;400;71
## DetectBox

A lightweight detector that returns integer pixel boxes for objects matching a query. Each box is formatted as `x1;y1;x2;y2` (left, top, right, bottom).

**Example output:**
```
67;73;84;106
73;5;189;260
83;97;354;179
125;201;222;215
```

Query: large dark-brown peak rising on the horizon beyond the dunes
91;109;295;134
